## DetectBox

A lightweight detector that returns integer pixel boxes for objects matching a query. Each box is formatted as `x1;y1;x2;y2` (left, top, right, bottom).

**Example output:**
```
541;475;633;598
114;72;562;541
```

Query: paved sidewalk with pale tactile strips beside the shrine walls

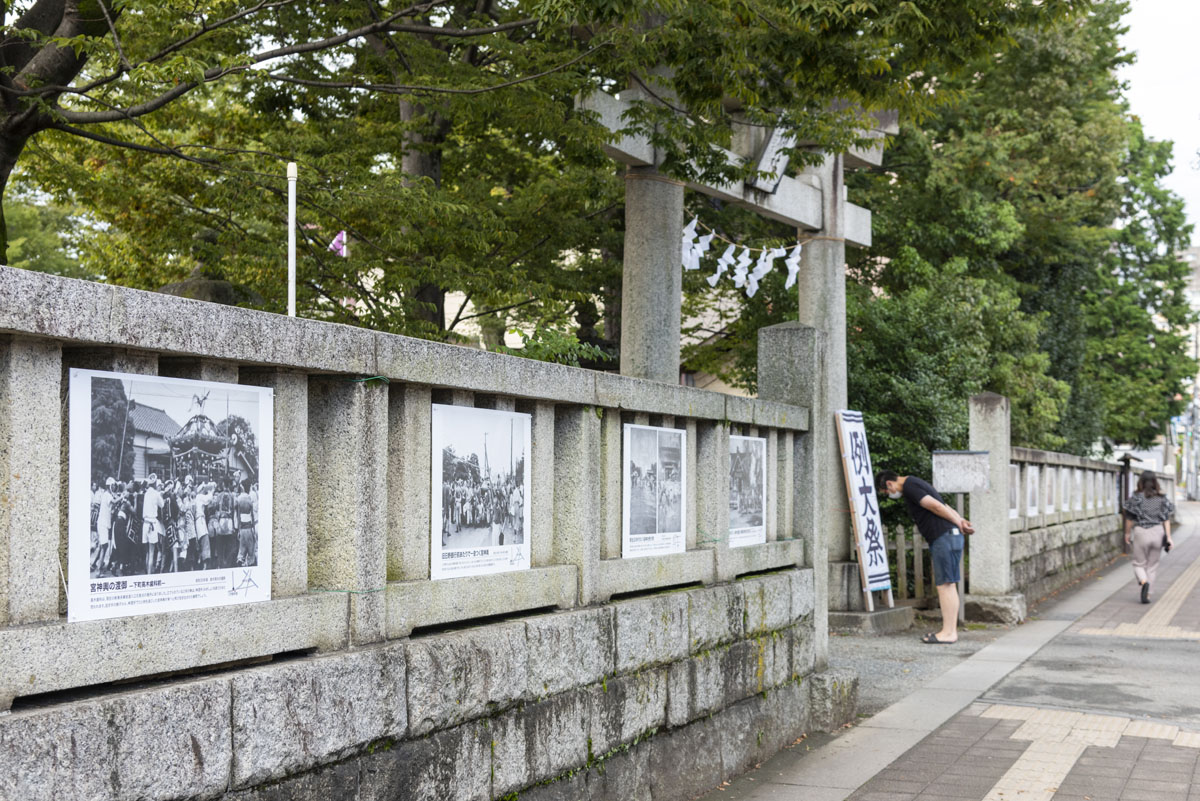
704;504;1200;801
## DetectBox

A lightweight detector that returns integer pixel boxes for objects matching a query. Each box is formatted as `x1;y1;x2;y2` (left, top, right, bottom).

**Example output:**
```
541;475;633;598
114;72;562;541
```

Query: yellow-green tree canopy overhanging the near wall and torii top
9;0;1079;350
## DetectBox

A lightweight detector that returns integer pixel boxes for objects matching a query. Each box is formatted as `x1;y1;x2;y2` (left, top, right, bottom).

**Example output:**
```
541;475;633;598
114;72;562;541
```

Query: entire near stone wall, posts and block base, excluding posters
0;267;857;800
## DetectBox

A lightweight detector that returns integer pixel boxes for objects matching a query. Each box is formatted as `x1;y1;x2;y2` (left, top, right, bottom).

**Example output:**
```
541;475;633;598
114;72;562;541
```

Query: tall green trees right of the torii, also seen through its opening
688;2;1194;474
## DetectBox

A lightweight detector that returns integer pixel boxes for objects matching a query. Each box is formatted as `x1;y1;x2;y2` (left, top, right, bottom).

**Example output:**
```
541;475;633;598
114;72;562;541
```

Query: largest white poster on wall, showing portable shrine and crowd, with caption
67;369;274;621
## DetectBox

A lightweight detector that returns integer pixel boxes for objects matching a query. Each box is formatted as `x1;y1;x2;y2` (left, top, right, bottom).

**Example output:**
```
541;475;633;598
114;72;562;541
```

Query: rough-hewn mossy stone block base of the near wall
0;568;854;801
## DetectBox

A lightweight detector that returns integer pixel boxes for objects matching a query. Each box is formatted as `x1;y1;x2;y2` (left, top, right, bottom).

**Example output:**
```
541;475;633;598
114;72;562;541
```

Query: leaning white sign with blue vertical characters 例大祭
836;410;892;591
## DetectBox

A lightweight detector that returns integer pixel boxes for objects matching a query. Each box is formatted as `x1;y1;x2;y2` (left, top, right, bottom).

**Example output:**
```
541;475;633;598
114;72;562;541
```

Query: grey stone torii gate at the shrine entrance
578;88;911;636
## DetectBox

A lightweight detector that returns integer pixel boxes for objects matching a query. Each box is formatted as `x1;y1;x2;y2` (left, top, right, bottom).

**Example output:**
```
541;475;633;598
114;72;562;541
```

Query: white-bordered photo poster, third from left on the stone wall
622;423;688;558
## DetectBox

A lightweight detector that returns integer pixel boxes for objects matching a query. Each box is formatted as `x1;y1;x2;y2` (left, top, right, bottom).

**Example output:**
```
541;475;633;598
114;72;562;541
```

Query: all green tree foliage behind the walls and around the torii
7;0;1195;472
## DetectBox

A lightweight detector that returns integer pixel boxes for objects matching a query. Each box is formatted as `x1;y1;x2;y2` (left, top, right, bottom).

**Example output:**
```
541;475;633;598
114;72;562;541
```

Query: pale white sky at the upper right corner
1121;0;1200;245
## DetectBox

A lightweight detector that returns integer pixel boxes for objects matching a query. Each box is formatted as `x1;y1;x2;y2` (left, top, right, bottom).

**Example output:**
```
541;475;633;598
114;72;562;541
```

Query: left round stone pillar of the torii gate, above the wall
620;167;684;384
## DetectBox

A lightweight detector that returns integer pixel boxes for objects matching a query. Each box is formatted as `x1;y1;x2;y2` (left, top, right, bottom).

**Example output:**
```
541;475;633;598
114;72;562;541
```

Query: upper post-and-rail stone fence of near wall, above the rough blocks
0;270;811;699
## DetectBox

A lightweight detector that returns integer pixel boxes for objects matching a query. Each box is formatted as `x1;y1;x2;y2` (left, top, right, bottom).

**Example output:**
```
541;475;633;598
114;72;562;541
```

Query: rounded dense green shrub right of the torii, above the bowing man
846;257;1067;475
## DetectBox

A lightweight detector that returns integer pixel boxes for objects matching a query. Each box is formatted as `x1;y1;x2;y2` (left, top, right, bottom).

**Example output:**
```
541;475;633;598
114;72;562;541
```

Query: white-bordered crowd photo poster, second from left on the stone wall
430;404;530;579
